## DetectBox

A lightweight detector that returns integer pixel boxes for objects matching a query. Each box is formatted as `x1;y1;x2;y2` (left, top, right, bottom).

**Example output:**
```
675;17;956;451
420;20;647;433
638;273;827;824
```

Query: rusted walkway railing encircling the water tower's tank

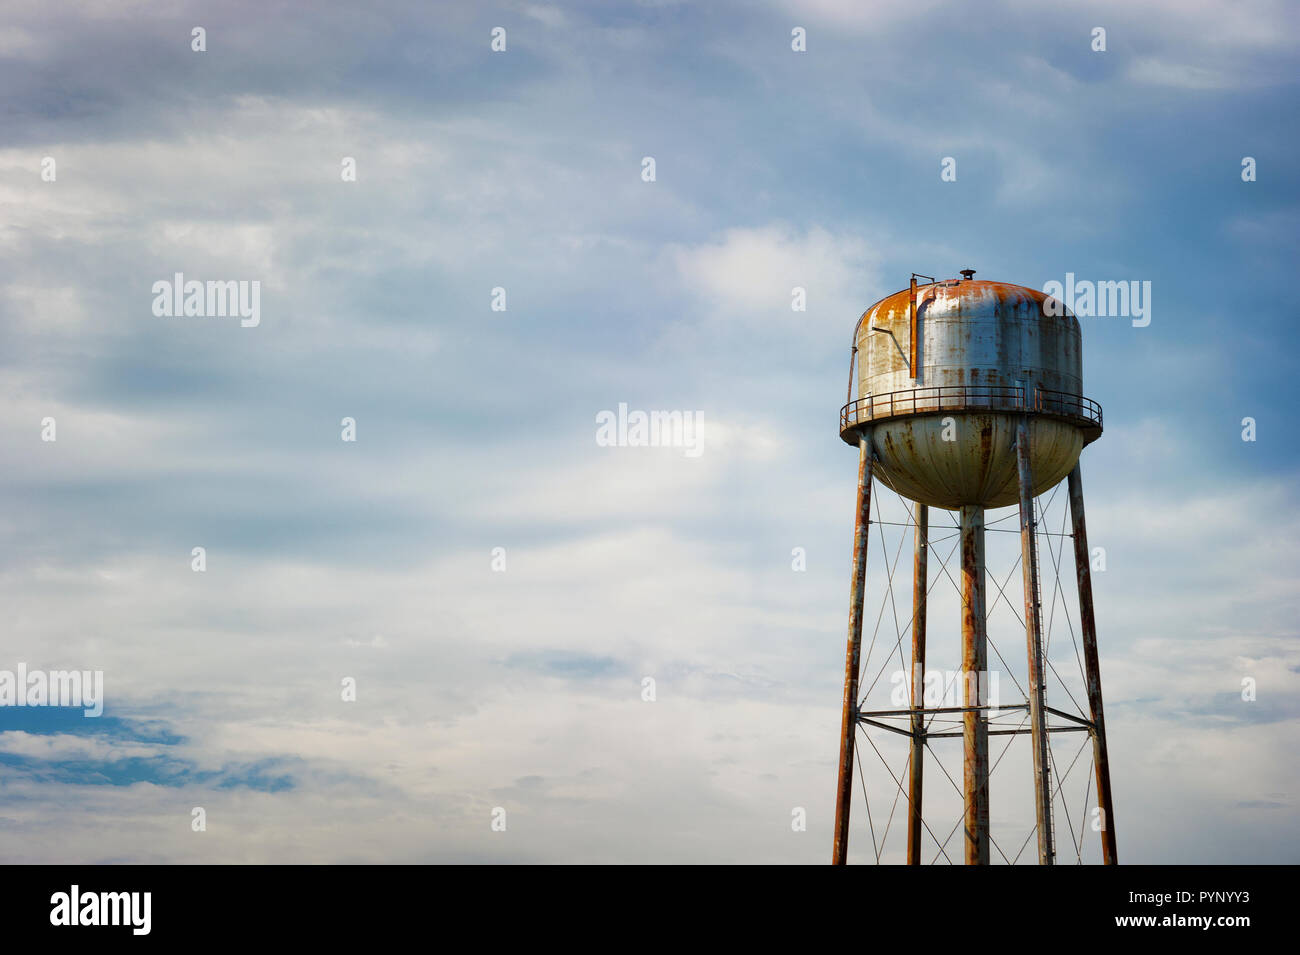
840;385;1101;431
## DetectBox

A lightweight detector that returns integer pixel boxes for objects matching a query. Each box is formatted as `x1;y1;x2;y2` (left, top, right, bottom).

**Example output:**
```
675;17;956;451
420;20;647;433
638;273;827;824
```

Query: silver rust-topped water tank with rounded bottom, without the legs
840;269;1101;509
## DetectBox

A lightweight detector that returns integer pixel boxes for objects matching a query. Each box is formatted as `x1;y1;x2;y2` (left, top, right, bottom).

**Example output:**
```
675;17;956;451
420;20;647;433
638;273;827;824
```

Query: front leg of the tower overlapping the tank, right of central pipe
1015;417;1056;865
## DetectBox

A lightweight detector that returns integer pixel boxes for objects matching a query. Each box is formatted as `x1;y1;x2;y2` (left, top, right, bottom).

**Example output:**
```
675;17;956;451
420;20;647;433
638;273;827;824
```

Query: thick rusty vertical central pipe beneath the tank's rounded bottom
961;504;989;865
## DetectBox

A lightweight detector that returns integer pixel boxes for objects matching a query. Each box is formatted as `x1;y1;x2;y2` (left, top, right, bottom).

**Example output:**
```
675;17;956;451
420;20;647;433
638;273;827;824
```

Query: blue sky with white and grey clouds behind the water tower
0;0;1300;863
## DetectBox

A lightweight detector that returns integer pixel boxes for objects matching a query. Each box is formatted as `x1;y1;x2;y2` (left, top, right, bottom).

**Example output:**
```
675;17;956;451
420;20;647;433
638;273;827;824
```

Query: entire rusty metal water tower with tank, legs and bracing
832;269;1115;864
